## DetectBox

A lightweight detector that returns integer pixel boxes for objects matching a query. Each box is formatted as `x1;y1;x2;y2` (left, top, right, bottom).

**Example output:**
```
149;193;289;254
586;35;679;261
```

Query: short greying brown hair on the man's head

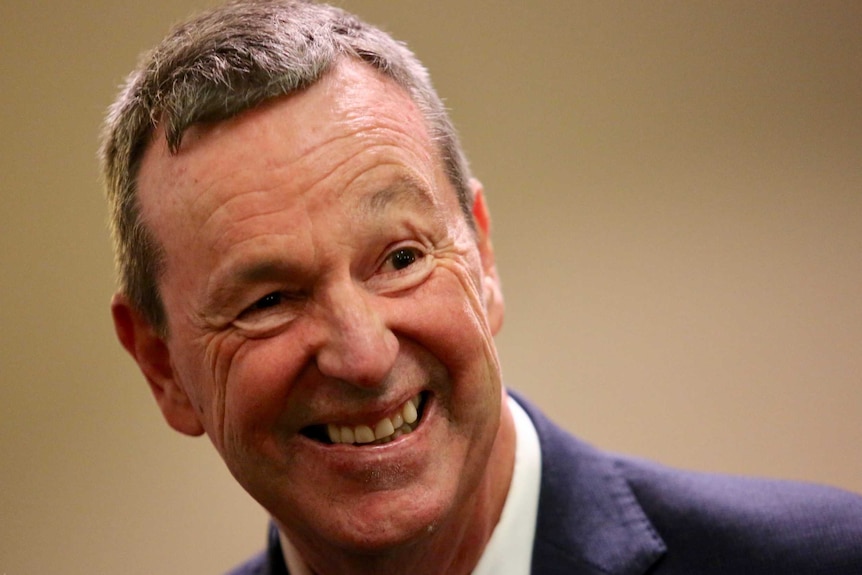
104;0;473;336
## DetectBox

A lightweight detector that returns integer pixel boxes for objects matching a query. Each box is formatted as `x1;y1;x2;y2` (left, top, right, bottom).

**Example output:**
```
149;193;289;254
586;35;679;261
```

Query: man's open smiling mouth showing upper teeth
301;393;427;445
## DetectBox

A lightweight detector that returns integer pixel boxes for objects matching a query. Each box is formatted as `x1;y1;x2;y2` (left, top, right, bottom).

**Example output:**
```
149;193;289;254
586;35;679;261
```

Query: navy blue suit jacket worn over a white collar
231;395;862;575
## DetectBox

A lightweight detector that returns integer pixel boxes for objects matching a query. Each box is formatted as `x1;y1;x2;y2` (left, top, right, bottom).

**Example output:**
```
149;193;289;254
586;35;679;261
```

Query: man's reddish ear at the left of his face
111;293;204;436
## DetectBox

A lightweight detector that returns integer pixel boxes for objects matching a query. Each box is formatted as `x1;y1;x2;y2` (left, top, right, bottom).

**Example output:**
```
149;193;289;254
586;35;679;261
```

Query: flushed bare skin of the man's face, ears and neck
112;61;514;574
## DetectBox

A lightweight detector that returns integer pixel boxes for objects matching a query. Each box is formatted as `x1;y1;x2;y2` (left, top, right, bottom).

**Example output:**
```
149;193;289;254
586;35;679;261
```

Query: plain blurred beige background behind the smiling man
0;0;862;575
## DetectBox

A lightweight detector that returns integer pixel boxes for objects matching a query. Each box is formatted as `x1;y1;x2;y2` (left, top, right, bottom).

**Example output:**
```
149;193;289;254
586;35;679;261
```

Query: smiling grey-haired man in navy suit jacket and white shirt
102;0;862;575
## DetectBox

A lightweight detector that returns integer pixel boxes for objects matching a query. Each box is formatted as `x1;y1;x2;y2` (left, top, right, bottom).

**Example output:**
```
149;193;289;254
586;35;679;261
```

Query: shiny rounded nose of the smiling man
316;280;398;388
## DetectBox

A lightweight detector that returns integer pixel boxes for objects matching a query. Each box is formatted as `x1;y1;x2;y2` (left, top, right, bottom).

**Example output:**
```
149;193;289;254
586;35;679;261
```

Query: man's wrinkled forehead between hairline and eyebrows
138;60;442;237
